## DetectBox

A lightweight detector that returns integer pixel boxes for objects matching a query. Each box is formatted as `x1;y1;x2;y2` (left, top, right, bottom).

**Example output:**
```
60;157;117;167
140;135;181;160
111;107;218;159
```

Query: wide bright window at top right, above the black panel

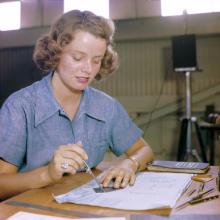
161;0;220;16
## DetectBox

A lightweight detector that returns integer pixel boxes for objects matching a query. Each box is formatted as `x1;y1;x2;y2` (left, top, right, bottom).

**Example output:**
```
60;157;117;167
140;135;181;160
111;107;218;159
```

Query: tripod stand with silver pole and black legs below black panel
177;71;207;162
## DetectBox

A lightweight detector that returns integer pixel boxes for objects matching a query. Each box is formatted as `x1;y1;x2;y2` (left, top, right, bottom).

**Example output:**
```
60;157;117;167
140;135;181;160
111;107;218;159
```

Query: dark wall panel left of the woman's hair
0;47;41;106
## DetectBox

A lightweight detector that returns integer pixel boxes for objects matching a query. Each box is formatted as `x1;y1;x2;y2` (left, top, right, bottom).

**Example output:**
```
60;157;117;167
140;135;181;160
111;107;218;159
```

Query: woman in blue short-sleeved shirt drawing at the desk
0;10;153;199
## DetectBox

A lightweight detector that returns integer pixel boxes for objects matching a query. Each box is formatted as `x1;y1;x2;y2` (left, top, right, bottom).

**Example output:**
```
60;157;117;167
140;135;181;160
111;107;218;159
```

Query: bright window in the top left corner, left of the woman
0;1;21;31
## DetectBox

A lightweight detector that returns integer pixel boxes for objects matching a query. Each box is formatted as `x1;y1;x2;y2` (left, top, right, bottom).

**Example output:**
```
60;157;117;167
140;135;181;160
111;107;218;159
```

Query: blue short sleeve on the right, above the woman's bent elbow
110;100;143;156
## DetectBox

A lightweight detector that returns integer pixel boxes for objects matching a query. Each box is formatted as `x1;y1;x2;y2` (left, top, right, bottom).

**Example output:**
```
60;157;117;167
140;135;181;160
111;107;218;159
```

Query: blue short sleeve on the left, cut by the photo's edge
0;101;26;166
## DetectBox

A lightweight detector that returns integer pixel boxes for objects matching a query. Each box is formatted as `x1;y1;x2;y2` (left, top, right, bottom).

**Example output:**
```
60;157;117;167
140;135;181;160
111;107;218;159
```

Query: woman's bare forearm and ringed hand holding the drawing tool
0;142;88;200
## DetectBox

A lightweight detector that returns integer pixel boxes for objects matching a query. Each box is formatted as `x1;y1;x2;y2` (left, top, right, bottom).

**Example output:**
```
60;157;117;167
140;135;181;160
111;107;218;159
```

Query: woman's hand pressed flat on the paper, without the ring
101;159;136;188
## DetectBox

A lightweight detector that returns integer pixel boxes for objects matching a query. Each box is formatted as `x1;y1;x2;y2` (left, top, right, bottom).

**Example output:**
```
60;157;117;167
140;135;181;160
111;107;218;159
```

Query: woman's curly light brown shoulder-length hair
33;10;118;80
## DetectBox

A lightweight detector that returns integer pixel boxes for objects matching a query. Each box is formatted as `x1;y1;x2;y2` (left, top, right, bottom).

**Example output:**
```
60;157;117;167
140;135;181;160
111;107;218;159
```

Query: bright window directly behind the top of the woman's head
64;0;109;18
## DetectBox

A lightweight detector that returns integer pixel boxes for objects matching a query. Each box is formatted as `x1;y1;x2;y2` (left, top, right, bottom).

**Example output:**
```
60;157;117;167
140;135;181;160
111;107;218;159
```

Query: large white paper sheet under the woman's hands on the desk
54;172;192;210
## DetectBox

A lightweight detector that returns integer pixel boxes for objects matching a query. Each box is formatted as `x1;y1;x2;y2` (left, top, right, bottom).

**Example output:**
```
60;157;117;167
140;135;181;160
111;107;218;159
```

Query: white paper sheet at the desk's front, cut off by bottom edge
7;212;126;220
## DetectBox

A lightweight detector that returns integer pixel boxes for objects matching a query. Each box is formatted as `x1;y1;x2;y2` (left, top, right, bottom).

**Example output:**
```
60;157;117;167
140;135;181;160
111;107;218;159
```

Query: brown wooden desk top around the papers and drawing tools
0;167;220;220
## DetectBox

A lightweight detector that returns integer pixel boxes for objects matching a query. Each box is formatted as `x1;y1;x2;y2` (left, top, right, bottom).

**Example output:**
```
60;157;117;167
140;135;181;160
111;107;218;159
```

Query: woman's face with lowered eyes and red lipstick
55;31;107;92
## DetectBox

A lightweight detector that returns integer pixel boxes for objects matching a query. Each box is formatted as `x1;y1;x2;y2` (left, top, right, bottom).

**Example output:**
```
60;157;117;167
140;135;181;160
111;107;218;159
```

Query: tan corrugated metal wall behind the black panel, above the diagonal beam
94;37;220;97
